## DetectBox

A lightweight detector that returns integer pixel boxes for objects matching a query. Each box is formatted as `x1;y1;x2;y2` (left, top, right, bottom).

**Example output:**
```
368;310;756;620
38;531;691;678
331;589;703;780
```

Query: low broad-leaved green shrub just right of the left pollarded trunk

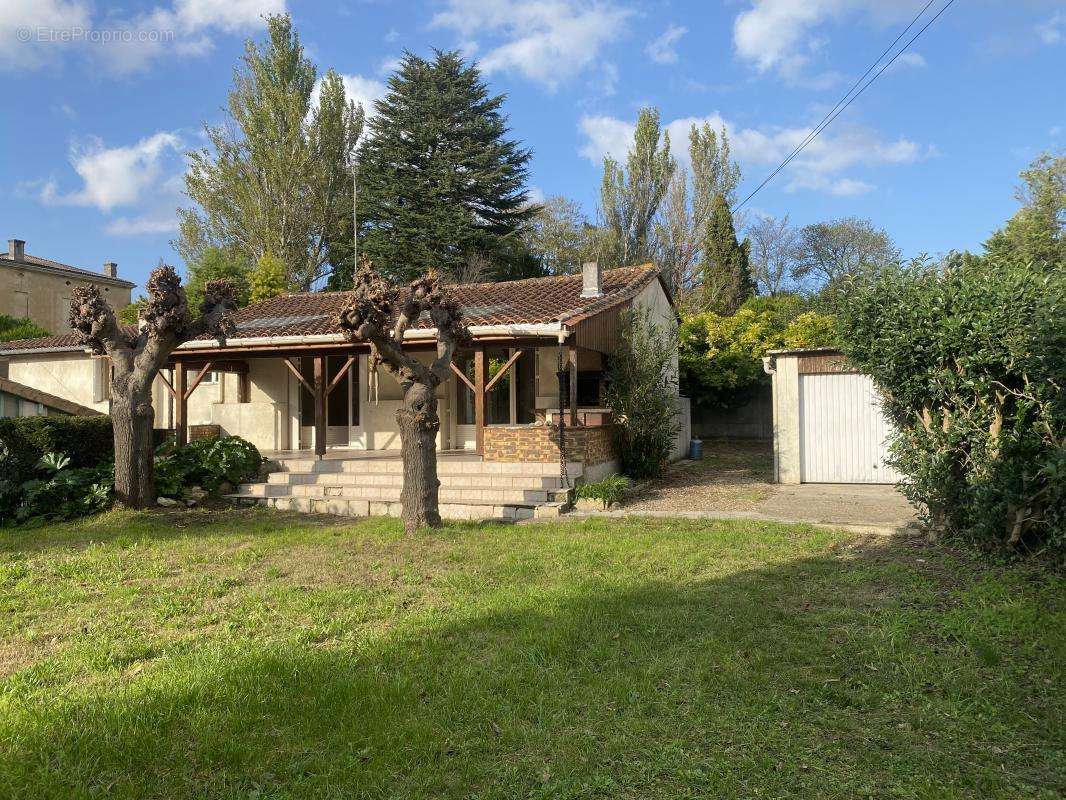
156;436;263;497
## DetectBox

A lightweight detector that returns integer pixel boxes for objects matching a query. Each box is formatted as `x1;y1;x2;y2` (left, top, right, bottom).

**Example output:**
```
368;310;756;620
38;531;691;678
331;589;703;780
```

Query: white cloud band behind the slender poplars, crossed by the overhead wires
579;113;932;196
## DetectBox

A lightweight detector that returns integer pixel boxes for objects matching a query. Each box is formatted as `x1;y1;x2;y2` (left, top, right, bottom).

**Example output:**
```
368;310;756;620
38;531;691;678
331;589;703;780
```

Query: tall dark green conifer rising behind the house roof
334;50;536;288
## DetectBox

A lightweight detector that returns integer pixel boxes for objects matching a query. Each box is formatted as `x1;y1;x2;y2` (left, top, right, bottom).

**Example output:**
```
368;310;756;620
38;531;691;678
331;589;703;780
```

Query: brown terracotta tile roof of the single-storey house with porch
0;263;659;355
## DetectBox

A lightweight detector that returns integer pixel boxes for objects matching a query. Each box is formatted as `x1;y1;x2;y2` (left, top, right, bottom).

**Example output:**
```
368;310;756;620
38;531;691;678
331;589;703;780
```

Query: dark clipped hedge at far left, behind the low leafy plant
0;416;114;483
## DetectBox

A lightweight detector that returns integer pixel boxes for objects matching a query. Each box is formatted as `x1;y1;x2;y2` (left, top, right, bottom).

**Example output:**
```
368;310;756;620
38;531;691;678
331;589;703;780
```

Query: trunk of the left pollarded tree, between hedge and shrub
111;393;156;509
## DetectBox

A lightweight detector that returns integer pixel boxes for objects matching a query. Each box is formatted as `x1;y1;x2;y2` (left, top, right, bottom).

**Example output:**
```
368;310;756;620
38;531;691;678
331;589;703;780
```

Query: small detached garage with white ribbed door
762;349;900;483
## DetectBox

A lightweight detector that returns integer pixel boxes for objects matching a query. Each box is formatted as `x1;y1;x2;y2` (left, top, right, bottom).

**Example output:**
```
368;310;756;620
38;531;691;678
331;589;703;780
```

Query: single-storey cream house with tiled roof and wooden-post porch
0;263;689;516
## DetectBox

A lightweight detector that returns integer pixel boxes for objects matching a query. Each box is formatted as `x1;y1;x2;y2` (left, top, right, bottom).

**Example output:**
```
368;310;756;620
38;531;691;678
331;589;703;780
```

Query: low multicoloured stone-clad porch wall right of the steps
484;426;616;466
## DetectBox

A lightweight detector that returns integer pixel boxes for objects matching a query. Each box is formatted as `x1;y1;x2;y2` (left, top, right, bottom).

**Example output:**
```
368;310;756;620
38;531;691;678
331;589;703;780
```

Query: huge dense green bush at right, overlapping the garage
838;255;1066;557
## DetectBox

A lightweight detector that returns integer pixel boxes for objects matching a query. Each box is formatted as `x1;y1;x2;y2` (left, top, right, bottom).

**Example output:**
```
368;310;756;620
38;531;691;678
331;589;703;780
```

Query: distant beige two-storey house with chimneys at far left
0;239;134;334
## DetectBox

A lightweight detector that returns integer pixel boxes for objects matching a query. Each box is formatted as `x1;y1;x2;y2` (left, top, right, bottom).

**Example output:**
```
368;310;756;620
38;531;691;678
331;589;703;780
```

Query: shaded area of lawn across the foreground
0;539;1066;798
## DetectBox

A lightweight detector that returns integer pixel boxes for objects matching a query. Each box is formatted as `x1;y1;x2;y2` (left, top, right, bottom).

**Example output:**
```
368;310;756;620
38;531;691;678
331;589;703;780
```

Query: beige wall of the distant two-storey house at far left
0;261;130;334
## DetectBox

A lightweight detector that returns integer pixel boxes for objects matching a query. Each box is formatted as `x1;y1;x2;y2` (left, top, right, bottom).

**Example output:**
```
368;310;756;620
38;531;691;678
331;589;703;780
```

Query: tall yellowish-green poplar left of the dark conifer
177;15;364;290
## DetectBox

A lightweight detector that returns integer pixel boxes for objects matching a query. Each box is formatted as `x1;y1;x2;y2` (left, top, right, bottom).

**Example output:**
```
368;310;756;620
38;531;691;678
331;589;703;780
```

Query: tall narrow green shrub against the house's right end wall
607;311;677;479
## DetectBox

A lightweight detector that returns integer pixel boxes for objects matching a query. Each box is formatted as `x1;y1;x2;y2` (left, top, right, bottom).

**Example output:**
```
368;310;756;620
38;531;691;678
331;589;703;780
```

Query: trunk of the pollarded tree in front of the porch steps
397;383;440;533
